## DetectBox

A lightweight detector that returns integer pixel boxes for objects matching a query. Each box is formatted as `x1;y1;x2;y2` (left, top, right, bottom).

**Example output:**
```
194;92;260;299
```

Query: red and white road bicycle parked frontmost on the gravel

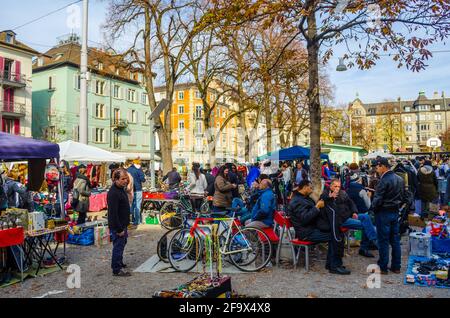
168;213;272;272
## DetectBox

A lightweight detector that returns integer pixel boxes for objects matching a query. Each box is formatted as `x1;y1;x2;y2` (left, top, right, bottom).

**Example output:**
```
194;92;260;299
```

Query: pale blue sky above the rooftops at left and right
0;0;450;105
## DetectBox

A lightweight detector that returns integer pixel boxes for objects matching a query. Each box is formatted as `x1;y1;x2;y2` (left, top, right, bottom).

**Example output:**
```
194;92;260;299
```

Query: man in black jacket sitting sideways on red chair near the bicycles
288;180;350;275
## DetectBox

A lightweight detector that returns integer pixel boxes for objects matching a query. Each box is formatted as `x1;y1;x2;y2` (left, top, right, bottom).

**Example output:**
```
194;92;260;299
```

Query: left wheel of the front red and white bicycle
168;229;202;272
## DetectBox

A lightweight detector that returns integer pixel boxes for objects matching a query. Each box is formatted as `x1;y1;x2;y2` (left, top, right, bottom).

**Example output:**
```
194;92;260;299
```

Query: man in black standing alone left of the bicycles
107;169;131;277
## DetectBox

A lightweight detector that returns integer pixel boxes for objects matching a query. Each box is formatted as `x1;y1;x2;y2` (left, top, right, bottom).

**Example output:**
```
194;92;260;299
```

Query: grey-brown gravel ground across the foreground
0;225;450;298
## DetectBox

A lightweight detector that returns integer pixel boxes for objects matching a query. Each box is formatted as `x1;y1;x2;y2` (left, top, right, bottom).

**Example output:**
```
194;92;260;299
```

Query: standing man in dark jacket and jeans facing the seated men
371;158;405;274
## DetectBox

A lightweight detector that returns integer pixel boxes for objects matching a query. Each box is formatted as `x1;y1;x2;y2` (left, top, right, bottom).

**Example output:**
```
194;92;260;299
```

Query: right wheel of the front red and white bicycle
228;227;272;272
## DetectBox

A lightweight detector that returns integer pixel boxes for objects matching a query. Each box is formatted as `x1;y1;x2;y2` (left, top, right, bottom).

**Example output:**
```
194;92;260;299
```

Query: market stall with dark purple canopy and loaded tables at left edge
0;133;67;286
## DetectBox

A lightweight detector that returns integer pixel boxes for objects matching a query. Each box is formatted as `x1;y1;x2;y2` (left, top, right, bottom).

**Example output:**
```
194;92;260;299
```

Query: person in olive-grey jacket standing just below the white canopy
73;164;91;224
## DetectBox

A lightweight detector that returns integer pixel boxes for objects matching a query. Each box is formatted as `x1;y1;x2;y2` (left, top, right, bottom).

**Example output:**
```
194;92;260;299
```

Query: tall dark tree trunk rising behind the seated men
307;10;322;199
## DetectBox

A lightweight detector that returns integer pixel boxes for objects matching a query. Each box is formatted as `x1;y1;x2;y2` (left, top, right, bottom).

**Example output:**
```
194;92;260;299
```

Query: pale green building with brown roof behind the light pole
32;35;158;160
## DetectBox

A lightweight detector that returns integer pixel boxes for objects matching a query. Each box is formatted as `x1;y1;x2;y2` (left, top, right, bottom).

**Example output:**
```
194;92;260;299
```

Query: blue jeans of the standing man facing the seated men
375;212;402;271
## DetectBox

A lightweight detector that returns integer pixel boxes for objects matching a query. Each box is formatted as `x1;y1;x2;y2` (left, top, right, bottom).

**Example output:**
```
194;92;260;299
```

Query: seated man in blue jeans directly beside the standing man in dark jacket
342;172;377;257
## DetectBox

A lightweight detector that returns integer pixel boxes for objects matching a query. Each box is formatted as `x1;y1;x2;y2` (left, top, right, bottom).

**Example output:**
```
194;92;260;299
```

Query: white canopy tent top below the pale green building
58;140;126;162
